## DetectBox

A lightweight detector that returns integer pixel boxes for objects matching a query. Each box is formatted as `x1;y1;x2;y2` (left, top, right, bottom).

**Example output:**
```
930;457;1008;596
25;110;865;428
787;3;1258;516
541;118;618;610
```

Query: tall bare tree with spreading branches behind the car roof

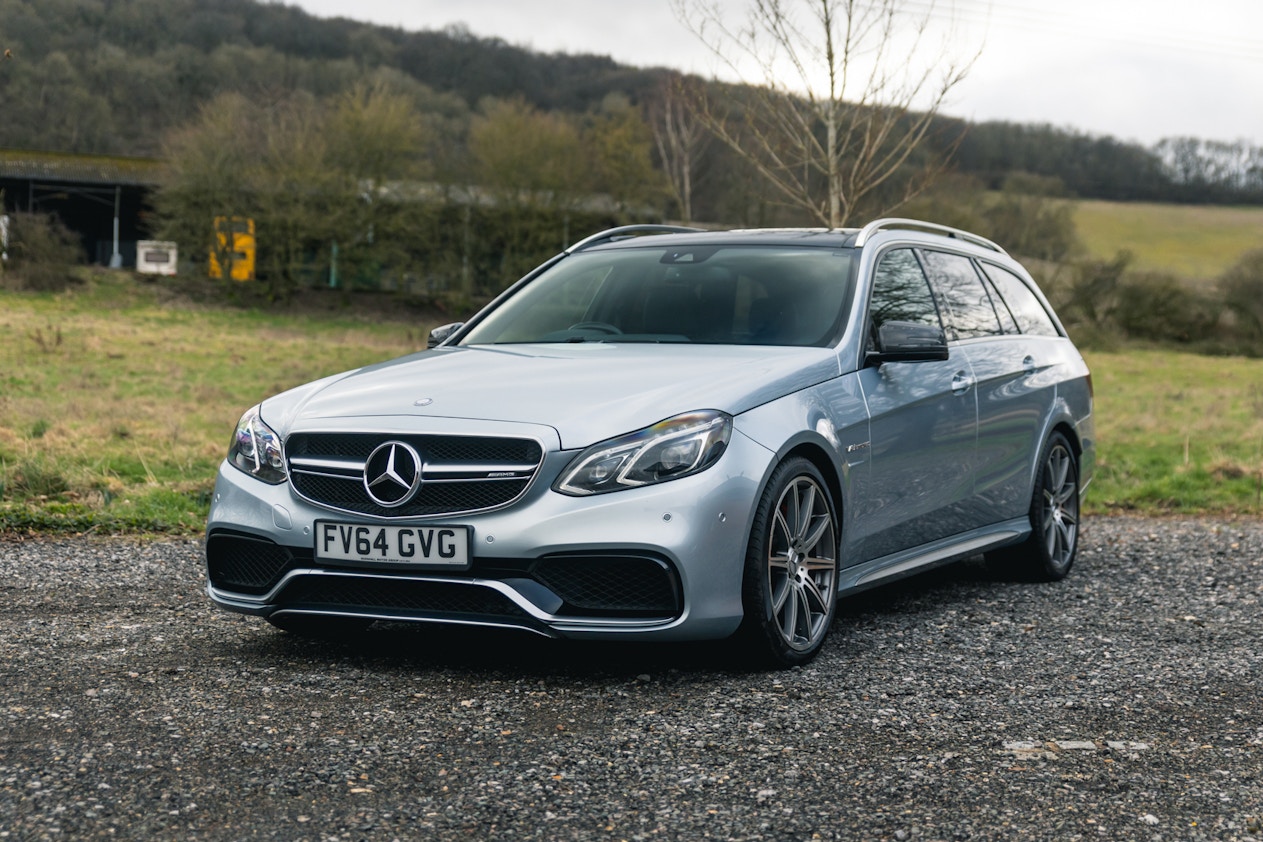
672;0;978;227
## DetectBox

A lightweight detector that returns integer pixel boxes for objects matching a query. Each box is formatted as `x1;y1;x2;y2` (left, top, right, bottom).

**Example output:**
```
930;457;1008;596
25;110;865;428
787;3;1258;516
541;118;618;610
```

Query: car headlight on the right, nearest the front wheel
553;410;733;496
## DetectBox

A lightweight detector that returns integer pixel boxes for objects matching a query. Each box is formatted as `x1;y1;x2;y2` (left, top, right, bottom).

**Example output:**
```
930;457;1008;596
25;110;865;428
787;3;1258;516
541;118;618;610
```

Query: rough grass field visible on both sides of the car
0;273;1263;534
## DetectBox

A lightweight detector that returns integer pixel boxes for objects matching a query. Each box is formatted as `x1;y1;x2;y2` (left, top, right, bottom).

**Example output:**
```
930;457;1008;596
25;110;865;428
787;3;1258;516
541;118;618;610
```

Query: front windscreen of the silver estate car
461;246;851;346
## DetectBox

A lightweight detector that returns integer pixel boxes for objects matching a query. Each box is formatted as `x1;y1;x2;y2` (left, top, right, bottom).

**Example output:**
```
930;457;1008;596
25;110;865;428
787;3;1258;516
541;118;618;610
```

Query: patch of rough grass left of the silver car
0;273;429;533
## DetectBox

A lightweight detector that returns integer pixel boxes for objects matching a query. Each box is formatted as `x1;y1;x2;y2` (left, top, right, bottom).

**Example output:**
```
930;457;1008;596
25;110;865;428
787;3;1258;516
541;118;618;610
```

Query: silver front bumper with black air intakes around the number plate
207;432;773;640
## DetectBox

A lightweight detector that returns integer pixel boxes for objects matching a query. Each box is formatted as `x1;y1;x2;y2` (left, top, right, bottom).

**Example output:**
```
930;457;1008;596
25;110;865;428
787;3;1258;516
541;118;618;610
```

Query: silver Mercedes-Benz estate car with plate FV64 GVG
206;220;1094;665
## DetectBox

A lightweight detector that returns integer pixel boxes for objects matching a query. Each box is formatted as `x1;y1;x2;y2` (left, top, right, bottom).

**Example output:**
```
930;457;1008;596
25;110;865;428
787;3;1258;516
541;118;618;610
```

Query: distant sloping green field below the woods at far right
1075;201;1263;280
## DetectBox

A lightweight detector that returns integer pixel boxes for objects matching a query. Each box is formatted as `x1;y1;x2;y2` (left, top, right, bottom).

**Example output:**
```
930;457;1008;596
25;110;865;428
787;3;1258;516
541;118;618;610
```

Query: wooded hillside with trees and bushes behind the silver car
7;0;1263;355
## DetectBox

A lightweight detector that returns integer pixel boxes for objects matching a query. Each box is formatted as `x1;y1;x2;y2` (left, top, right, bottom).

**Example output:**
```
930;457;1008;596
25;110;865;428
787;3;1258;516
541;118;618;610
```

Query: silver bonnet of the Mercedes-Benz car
264;343;839;449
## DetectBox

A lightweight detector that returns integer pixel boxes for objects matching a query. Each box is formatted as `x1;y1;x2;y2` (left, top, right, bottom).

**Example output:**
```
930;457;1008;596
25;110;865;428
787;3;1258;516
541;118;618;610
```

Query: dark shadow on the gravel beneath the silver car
219;558;1022;678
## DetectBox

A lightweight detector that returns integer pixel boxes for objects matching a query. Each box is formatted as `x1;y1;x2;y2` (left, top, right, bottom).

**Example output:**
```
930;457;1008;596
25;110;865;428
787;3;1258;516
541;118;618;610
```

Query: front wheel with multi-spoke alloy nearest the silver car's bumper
738;458;839;667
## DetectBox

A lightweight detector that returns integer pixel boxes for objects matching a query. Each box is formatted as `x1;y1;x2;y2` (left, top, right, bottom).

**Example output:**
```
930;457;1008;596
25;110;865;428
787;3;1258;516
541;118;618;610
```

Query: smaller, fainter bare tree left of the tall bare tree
649;74;710;223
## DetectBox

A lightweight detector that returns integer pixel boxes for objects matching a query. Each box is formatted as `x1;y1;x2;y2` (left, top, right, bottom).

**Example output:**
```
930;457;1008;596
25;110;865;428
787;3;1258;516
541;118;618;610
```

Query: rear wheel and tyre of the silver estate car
986;433;1079;582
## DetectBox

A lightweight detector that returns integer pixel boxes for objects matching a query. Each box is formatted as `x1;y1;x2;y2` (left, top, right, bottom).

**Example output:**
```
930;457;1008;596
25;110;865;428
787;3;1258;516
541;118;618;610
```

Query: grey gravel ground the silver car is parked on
0;519;1263;841
